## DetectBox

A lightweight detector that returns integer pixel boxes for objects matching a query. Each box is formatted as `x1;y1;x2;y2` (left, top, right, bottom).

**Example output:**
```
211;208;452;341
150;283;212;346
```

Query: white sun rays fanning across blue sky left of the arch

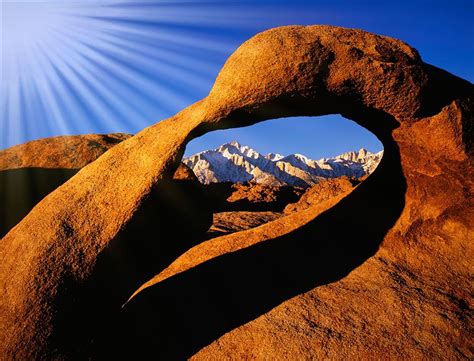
0;1;318;148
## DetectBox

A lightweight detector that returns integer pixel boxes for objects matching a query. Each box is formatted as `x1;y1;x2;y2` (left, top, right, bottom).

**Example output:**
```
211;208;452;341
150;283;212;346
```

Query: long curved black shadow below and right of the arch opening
104;112;406;359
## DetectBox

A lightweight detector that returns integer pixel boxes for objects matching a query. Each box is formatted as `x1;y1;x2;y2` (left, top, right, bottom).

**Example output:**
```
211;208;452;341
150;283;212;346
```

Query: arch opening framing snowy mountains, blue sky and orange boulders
182;114;383;239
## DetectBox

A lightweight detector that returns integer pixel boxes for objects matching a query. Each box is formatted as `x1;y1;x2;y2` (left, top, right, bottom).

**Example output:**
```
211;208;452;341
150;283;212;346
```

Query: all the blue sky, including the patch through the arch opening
0;0;474;158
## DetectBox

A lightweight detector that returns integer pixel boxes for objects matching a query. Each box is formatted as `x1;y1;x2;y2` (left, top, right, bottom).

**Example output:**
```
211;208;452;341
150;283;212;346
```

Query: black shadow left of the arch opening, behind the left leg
46;175;212;359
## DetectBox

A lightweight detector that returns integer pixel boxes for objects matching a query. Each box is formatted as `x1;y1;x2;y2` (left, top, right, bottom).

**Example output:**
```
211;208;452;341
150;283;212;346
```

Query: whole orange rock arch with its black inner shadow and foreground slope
0;26;474;359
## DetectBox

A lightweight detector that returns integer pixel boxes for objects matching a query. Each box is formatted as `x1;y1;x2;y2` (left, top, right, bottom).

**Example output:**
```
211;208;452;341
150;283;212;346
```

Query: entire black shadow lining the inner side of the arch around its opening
0;105;400;359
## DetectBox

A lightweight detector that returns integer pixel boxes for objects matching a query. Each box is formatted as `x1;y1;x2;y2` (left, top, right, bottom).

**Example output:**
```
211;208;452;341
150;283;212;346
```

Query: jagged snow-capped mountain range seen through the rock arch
183;141;383;187
